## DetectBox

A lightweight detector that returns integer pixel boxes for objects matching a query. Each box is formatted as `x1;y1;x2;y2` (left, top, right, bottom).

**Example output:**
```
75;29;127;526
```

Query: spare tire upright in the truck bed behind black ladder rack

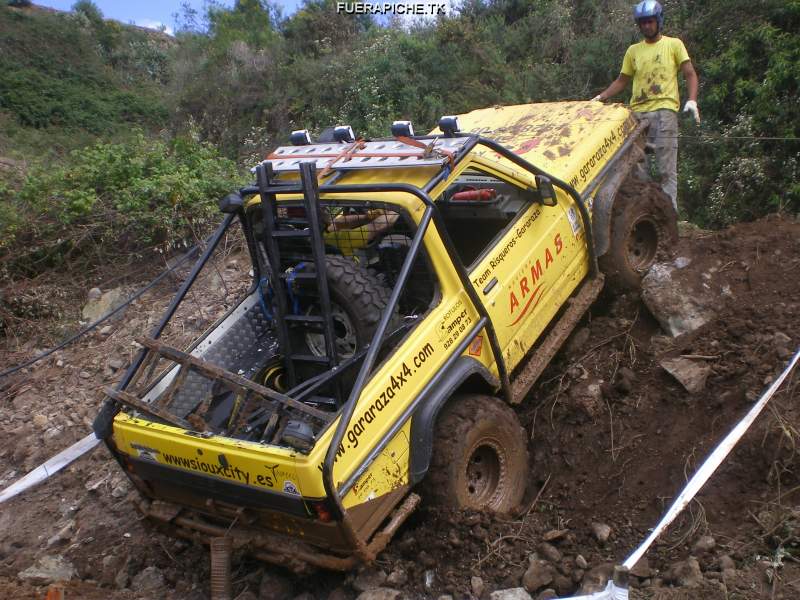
292;256;391;360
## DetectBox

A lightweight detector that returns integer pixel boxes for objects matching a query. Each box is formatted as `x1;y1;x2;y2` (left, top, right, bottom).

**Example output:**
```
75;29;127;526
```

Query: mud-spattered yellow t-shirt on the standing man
621;35;689;112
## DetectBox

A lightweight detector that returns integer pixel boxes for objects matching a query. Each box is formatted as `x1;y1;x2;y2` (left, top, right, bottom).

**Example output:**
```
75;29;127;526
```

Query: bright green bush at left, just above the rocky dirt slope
0;133;239;271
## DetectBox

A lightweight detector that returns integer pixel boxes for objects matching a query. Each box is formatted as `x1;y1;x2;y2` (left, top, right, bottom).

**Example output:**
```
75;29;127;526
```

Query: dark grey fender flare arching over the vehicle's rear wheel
409;356;500;485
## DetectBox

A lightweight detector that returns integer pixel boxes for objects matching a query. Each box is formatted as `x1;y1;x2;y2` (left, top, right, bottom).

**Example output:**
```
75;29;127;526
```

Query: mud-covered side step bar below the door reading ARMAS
511;273;605;404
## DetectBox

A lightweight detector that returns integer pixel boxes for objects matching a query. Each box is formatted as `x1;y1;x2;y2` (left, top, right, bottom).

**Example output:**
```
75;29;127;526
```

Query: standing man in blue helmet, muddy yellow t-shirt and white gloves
592;0;700;211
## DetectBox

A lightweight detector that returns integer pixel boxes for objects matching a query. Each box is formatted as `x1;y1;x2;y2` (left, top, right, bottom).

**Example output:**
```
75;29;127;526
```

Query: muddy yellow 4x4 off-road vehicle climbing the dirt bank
95;102;677;569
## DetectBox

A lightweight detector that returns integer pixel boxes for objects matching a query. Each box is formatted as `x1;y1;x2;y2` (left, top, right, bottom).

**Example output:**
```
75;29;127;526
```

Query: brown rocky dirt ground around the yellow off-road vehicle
0;217;800;600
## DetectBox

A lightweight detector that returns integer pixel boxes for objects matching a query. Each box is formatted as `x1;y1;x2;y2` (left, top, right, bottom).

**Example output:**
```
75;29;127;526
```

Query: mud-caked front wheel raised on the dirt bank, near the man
599;178;678;291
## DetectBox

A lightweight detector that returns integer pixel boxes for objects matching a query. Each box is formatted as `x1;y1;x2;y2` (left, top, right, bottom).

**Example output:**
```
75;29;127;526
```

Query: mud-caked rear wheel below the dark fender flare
423;394;528;513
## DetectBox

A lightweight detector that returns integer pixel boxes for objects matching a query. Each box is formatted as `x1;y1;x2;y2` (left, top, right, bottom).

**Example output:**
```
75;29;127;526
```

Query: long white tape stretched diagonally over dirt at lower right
622;348;800;569
